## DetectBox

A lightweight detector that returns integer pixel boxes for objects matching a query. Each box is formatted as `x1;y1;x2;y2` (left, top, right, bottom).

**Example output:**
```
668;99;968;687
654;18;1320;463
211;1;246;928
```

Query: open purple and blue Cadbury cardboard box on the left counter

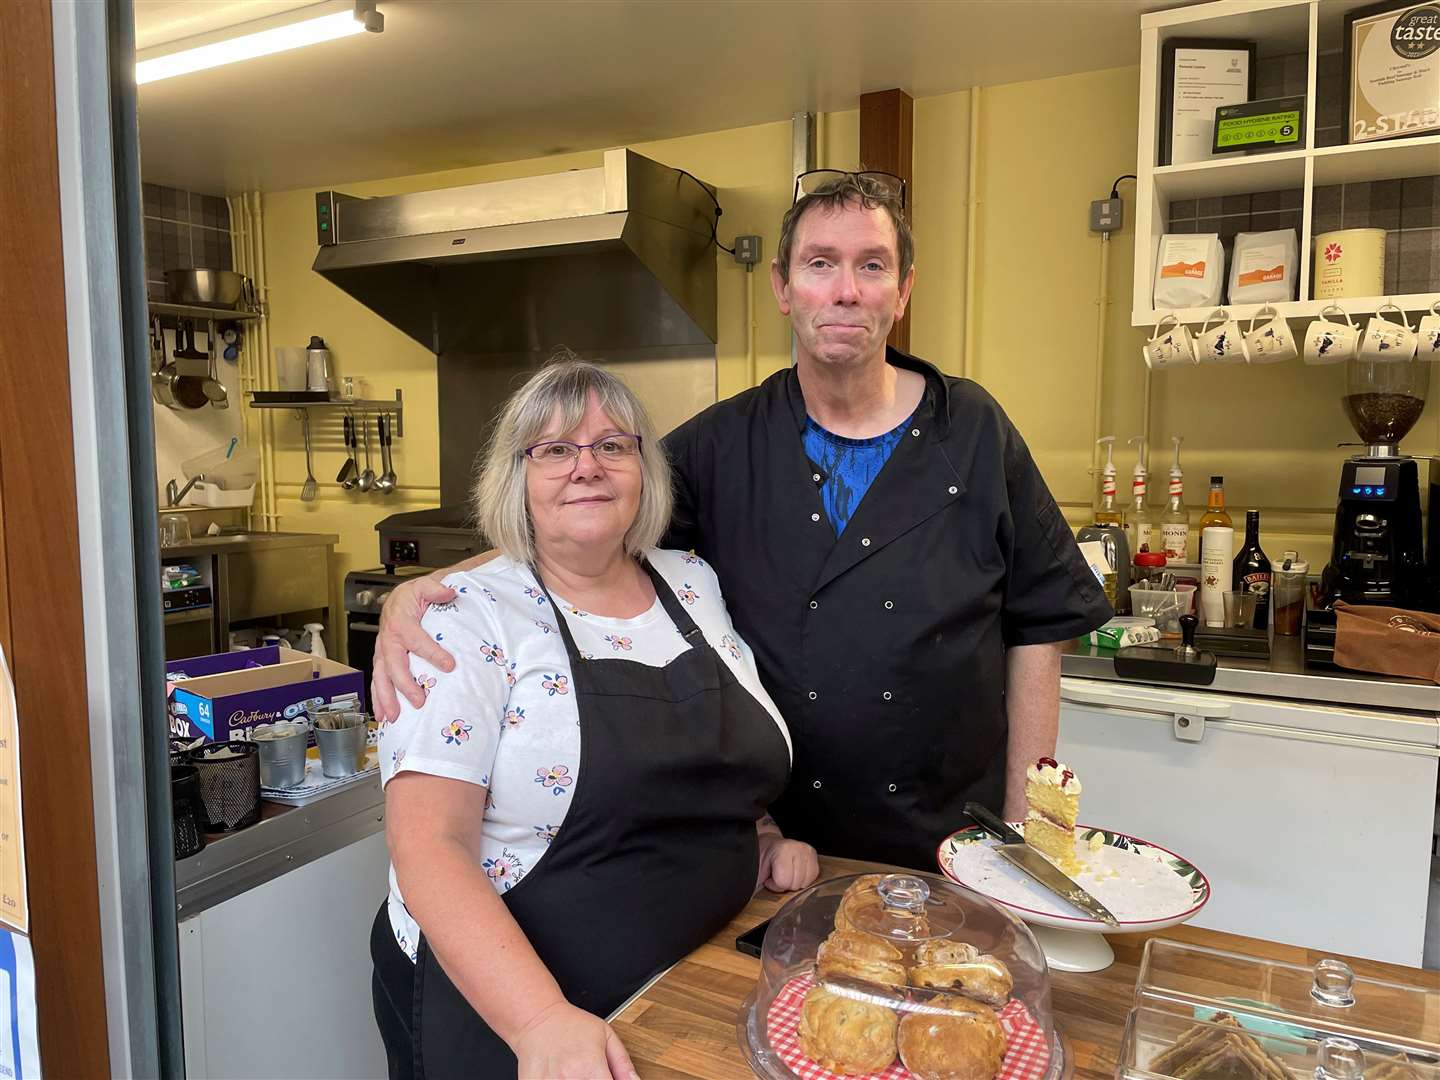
166;645;364;743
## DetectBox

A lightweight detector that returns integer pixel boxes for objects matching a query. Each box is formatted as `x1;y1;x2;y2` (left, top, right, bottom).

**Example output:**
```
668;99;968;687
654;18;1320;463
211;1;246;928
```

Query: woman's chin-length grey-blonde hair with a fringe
472;357;671;563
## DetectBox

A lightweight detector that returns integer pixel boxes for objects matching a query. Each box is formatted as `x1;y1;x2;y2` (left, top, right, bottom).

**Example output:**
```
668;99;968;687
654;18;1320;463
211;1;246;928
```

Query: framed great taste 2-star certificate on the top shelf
1345;0;1440;143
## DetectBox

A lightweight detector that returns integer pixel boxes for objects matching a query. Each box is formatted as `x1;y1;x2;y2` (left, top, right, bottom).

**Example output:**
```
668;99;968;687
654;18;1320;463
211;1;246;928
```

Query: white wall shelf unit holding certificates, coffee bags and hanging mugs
1130;0;1440;327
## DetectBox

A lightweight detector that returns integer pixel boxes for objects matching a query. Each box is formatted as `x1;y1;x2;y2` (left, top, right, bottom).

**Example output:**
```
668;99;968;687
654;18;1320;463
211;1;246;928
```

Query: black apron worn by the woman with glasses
372;562;789;1080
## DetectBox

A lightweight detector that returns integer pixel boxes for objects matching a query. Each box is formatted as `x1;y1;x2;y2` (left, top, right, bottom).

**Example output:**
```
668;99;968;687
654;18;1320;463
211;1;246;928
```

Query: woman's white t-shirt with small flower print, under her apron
379;549;791;960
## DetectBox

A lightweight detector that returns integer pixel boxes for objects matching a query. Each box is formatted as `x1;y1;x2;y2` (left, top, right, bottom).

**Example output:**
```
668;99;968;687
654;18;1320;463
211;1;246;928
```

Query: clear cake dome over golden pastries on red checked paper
739;871;1064;1080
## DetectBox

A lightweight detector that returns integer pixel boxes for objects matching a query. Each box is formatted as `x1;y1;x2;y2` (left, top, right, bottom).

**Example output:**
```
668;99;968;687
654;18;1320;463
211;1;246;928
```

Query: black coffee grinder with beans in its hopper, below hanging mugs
1320;357;1436;608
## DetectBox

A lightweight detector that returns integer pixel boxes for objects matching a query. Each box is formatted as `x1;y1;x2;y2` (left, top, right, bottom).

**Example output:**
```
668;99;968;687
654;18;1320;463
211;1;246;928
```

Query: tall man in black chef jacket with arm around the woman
373;171;1110;870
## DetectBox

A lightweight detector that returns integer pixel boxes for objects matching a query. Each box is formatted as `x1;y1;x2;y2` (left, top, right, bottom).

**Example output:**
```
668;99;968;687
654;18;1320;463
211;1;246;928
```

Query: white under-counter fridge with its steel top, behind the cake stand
1057;642;1440;968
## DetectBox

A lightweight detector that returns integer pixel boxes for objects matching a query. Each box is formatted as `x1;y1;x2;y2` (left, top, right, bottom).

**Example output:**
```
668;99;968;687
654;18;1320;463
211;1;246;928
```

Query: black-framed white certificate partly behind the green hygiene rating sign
1156;37;1256;166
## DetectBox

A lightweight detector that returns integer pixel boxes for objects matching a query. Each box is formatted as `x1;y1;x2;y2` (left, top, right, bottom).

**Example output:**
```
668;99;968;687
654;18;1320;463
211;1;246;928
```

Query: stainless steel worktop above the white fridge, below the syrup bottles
1060;638;1440;714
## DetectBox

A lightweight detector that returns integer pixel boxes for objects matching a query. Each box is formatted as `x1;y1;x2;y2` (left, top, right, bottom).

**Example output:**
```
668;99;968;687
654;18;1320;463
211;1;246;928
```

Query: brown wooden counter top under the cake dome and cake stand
613;858;1440;1080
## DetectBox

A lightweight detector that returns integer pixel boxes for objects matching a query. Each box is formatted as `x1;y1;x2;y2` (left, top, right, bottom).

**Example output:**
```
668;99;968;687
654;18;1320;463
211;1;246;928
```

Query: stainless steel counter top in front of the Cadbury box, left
176;772;384;919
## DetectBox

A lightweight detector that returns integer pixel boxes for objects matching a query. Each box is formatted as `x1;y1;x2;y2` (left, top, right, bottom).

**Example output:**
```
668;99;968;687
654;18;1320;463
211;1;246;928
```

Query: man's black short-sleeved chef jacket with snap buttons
664;348;1112;870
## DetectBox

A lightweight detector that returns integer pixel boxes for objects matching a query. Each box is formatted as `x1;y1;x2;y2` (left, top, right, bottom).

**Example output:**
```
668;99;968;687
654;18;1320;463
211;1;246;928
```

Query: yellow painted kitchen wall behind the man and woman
264;68;1440;642
